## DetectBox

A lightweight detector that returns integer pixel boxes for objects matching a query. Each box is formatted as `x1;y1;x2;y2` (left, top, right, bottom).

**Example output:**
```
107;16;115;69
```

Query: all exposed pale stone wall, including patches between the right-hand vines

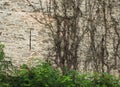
0;0;120;76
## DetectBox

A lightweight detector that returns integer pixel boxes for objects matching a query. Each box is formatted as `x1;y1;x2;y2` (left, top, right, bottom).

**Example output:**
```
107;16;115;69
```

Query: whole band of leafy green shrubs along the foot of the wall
0;44;120;87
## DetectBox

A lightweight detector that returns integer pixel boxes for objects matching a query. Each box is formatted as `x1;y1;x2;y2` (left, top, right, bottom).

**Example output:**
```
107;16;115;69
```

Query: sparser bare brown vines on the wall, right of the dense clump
86;0;120;73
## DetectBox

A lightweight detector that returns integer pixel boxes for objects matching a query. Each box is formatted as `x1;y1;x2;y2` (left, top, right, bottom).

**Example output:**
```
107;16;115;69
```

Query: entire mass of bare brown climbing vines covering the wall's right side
26;0;120;73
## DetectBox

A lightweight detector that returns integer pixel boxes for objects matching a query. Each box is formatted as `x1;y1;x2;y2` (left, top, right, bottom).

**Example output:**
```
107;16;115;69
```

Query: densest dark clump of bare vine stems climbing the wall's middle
47;0;84;73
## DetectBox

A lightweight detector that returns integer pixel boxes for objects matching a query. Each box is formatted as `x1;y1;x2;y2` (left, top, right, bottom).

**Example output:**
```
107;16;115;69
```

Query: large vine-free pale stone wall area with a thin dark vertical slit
0;0;50;66
